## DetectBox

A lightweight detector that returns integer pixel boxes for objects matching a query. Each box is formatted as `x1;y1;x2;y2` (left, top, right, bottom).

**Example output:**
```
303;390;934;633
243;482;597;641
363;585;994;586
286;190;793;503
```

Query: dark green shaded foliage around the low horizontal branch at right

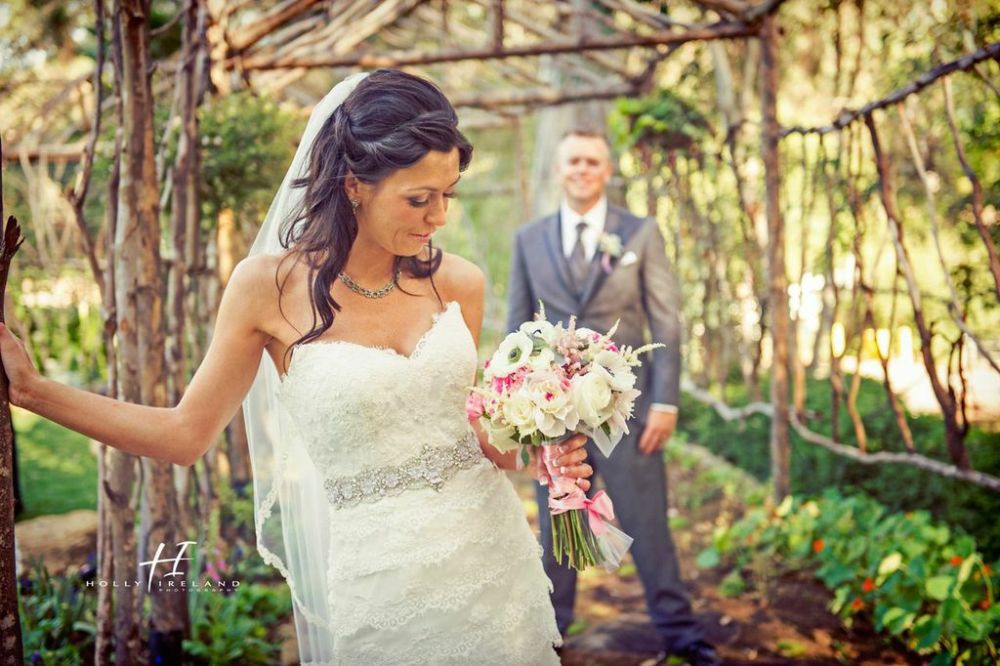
678;379;1000;557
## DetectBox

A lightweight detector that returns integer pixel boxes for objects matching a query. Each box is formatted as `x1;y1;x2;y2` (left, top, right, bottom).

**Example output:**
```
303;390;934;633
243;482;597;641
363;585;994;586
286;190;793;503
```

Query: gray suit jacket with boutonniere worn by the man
507;205;681;412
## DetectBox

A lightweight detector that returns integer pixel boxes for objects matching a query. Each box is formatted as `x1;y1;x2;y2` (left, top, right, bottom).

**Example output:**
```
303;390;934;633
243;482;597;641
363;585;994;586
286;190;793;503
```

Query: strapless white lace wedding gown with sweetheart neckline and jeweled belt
279;301;560;666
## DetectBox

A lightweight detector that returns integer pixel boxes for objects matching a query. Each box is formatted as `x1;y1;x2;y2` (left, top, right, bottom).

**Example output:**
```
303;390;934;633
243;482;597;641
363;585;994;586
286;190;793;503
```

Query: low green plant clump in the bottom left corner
18;562;97;666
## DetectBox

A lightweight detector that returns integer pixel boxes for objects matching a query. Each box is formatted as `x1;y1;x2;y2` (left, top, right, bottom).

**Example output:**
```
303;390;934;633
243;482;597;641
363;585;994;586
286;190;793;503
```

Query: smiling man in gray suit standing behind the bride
507;129;720;665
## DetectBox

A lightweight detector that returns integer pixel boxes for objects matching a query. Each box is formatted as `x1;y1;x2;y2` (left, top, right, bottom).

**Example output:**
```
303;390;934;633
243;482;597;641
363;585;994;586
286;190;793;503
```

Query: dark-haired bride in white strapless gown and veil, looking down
0;69;591;665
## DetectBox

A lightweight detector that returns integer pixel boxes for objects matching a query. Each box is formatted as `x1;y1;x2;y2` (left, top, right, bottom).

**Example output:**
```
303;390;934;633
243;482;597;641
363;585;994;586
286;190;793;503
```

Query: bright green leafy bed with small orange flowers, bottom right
699;490;1000;663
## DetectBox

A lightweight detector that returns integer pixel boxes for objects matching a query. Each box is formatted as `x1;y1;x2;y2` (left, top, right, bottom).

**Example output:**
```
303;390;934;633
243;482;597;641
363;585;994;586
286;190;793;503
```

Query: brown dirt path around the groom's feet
517;440;919;666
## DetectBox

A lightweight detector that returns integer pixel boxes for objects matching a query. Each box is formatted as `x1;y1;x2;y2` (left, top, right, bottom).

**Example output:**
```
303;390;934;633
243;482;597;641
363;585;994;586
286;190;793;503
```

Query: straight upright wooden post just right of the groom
761;14;790;499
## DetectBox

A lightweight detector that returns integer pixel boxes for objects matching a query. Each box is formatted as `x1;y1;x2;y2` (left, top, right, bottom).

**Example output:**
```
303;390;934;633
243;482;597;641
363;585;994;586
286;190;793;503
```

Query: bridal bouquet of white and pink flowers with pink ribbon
466;306;662;570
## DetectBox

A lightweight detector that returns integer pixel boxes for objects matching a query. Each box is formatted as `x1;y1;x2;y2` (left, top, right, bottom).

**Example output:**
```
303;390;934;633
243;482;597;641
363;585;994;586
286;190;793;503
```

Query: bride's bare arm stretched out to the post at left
0;257;275;465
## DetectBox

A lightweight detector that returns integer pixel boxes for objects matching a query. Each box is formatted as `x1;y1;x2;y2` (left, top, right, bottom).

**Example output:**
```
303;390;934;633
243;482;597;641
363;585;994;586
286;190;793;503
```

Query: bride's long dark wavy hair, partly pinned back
275;69;472;349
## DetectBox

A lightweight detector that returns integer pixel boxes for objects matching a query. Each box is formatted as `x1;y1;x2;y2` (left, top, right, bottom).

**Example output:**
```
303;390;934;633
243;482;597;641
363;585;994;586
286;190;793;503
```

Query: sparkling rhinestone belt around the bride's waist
323;430;484;509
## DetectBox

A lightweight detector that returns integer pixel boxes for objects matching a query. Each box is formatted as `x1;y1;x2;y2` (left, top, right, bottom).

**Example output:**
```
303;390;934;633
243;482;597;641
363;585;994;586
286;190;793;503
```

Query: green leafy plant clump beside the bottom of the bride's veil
184;584;292;665
